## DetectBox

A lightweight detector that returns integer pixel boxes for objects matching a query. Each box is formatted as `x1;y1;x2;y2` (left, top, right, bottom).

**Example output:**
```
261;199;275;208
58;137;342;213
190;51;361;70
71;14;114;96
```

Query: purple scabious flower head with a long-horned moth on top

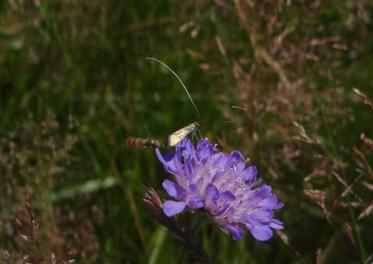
156;138;284;241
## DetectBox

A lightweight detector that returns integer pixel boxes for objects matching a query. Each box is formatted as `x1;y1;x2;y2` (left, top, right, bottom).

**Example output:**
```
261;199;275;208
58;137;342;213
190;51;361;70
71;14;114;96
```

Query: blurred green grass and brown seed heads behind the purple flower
0;0;373;263
